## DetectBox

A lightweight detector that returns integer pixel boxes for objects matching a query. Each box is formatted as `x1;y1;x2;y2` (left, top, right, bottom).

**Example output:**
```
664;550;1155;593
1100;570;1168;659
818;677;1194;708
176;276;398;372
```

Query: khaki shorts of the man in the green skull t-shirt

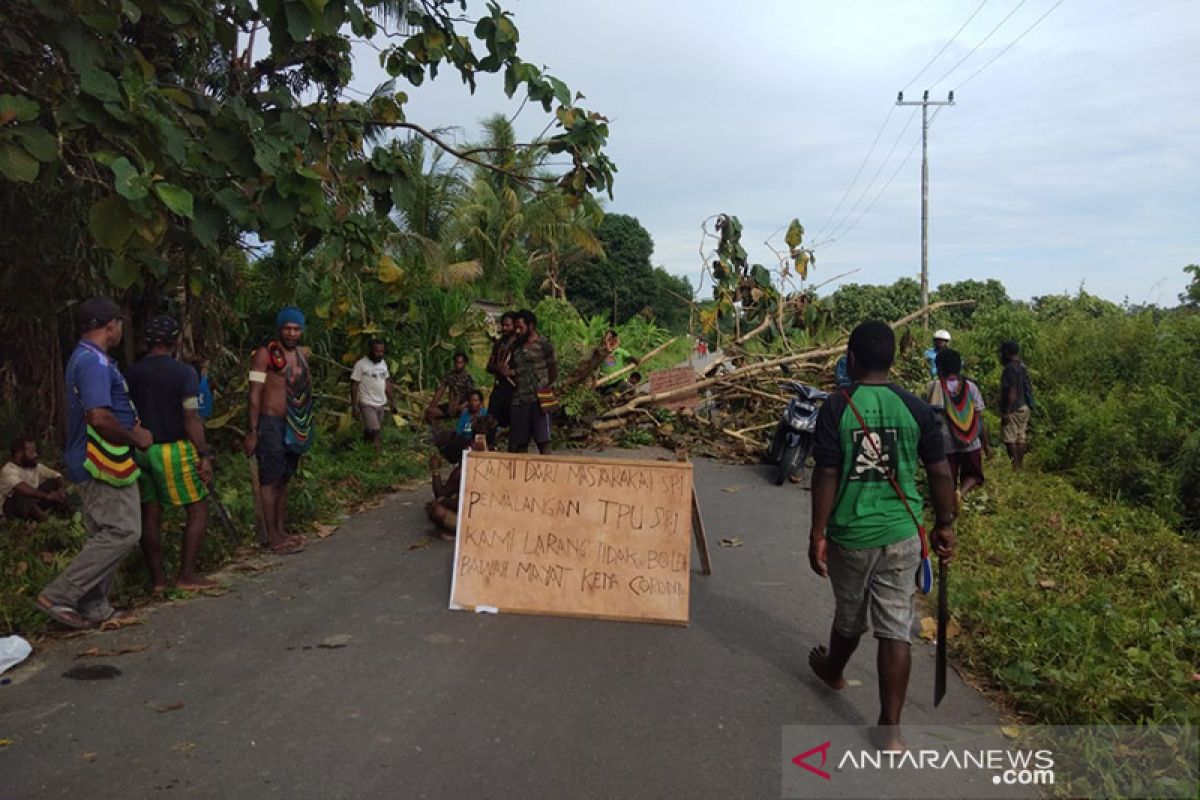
827;536;920;642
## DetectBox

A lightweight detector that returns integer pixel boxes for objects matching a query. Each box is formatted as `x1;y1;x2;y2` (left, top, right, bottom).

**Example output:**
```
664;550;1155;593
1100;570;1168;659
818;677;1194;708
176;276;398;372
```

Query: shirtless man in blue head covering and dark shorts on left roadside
245;306;312;555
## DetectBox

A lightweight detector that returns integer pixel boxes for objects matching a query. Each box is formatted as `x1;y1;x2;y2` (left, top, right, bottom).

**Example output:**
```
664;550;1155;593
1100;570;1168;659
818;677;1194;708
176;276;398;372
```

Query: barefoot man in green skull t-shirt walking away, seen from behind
809;320;955;750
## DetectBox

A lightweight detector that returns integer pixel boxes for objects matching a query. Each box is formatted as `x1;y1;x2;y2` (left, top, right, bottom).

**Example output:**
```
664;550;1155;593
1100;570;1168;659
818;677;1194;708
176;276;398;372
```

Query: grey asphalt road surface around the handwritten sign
0;452;1022;799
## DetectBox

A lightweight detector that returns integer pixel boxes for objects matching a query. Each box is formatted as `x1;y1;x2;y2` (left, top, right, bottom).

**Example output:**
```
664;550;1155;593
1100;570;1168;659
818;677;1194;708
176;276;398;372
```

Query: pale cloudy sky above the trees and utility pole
352;0;1200;305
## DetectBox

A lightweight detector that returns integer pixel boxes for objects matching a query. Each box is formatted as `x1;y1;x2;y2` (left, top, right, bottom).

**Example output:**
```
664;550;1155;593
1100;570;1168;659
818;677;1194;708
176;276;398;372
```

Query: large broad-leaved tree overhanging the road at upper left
0;0;613;434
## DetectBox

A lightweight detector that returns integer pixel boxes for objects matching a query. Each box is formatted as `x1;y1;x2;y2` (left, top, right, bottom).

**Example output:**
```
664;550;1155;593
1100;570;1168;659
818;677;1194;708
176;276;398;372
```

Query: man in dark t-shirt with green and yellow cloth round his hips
127;317;217;594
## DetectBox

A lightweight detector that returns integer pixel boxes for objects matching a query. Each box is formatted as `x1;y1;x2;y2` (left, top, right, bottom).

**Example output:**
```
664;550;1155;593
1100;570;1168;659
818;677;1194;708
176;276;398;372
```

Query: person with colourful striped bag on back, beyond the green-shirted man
925;348;991;499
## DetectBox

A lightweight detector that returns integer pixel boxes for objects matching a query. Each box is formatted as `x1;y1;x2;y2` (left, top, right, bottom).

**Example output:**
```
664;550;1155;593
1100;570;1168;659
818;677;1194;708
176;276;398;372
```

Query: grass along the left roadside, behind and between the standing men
0;426;427;637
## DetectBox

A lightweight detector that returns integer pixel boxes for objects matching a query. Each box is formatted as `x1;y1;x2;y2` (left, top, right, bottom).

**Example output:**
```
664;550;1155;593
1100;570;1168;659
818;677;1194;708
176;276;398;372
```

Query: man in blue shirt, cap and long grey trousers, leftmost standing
37;297;154;628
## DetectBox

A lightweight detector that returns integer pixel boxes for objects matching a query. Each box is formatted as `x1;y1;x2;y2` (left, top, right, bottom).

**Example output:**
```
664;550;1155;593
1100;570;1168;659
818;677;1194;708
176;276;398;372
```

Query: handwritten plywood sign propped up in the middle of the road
450;452;691;625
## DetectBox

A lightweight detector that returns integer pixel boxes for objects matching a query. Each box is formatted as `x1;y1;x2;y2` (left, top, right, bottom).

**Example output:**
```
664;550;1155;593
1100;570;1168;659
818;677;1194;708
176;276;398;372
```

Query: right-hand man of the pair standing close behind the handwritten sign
505;308;558;455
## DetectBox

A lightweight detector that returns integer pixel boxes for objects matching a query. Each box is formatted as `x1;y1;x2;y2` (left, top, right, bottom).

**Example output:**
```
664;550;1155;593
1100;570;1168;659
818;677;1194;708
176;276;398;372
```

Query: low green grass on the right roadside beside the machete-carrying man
950;457;1200;724
